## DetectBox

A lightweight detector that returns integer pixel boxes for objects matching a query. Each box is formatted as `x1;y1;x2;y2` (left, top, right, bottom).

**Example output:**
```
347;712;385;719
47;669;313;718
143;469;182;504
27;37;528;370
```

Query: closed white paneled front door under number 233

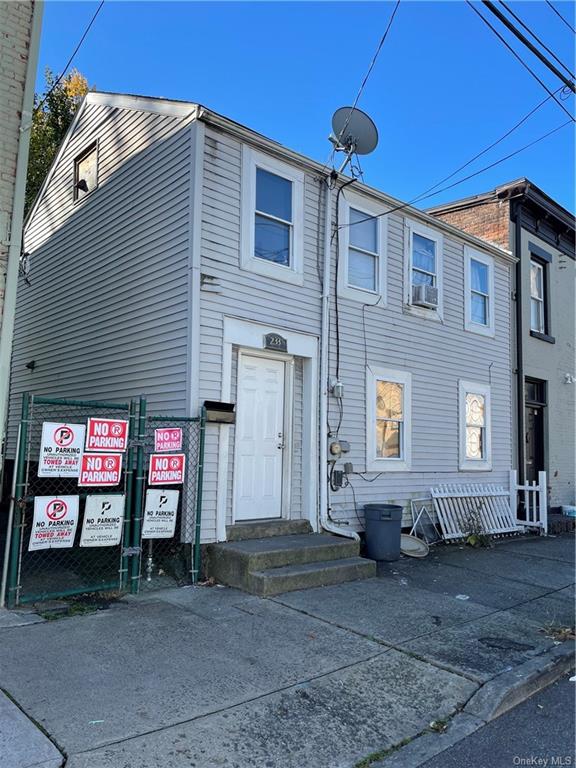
234;355;285;520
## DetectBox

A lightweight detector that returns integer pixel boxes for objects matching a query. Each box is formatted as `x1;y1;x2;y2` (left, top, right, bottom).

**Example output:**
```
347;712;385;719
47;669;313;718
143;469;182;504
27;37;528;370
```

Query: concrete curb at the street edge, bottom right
371;641;575;768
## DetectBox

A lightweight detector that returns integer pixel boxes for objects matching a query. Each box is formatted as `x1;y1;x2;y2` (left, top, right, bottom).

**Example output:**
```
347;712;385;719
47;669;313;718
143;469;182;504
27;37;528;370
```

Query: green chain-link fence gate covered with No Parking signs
1;393;205;607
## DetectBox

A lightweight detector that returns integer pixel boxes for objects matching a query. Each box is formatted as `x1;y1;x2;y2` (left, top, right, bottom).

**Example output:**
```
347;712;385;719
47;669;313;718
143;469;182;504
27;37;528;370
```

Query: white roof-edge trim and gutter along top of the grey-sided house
26;91;516;262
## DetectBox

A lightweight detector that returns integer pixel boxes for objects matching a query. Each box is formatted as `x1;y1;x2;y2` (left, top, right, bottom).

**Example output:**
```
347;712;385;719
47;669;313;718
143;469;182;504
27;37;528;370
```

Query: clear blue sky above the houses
37;0;575;210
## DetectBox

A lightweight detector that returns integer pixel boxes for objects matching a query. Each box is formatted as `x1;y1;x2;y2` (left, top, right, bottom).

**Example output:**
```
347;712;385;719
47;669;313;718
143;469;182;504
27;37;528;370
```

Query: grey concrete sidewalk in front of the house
0;536;574;768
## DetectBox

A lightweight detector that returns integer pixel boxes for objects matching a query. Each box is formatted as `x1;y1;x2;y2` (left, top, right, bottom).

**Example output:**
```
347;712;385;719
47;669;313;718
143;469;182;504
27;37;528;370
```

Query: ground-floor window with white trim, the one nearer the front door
366;367;412;472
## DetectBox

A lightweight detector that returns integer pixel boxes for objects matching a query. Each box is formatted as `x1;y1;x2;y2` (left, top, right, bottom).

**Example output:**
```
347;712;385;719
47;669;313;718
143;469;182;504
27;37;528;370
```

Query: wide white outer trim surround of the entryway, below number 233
216;315;319;541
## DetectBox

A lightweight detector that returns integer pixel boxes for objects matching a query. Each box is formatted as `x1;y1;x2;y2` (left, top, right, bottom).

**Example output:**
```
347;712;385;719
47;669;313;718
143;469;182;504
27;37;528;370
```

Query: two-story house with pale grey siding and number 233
5;93;514;556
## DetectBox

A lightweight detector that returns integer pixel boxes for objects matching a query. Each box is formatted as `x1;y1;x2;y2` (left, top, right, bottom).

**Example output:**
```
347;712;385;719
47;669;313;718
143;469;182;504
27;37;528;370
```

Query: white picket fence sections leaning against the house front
430;471;548;541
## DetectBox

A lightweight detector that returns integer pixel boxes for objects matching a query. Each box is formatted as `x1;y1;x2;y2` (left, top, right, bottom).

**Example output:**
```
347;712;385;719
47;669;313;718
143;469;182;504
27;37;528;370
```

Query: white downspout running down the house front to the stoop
318;178;360;541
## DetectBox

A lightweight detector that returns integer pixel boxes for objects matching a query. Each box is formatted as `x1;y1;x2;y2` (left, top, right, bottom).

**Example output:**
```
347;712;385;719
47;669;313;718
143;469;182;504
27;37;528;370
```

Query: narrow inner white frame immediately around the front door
232;347;294;525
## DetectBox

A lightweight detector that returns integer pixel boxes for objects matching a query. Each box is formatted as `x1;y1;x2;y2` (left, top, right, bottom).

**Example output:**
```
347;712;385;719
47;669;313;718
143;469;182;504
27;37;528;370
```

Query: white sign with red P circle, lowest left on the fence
28;496;79;552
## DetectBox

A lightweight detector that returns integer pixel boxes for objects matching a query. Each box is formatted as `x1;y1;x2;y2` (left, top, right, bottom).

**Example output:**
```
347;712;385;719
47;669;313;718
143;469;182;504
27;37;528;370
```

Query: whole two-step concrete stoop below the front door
207;533;376;597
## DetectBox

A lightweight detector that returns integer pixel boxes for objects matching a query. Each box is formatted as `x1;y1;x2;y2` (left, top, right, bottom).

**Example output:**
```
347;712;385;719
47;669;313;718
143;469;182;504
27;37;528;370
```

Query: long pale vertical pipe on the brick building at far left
0;0;44;478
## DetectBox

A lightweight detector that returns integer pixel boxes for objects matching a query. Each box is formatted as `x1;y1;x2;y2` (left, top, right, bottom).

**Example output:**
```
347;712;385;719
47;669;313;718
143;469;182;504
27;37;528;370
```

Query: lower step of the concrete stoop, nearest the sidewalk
248;557;376;597
